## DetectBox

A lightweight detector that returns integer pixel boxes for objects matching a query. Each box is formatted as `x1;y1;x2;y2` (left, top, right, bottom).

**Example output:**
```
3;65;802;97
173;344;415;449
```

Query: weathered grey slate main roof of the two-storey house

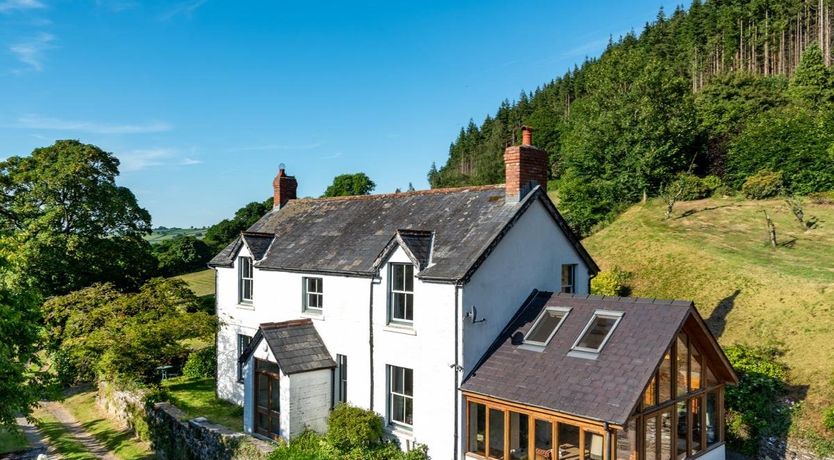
209;185;599;281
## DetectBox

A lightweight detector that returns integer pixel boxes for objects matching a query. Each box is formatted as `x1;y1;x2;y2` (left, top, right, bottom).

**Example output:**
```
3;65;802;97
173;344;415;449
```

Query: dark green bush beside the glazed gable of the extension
725;345;791;455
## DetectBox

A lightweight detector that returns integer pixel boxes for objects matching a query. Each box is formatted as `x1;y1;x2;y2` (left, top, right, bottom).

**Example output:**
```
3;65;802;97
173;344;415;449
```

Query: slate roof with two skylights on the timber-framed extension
461;291;735;424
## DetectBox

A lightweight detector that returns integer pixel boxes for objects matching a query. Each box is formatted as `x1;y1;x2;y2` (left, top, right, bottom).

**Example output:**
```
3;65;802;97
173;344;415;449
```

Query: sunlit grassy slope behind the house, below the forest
584;199;834;438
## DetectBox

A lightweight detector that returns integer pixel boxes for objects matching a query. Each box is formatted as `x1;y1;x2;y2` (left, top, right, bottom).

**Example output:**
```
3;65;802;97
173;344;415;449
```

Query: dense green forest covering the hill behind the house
428;0;834;234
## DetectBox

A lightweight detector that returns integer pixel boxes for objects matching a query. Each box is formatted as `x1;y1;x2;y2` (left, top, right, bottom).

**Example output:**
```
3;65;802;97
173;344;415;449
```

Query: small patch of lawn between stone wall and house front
162;377;243;431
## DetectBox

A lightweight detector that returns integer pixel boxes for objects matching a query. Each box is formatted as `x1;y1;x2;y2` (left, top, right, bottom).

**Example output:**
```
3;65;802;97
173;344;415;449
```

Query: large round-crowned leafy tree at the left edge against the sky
0;140;155;295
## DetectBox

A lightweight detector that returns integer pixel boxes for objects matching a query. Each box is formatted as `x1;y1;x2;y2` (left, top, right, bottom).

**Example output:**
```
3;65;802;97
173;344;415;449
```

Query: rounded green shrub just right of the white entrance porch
327;404;383;450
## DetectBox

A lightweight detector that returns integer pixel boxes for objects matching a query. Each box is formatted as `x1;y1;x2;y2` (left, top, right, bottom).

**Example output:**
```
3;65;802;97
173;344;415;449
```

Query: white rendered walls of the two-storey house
216;197;589;458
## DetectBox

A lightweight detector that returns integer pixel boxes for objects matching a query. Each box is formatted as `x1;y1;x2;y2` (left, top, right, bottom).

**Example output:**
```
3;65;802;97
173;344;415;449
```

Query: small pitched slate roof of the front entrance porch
238;319;336;375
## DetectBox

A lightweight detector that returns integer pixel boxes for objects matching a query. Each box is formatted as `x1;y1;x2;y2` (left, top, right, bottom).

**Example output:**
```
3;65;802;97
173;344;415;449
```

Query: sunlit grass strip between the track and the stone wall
64;391;153;460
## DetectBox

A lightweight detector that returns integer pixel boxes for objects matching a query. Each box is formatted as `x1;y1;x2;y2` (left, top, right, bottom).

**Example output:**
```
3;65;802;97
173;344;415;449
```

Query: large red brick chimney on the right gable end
504;126;548;201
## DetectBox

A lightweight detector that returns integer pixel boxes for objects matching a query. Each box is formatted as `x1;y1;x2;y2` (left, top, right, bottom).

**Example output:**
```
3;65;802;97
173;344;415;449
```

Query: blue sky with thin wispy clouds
0;0;680;227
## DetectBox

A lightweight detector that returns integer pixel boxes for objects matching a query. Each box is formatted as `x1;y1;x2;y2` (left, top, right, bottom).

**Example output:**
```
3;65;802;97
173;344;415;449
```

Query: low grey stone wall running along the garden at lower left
96;382;275;460
